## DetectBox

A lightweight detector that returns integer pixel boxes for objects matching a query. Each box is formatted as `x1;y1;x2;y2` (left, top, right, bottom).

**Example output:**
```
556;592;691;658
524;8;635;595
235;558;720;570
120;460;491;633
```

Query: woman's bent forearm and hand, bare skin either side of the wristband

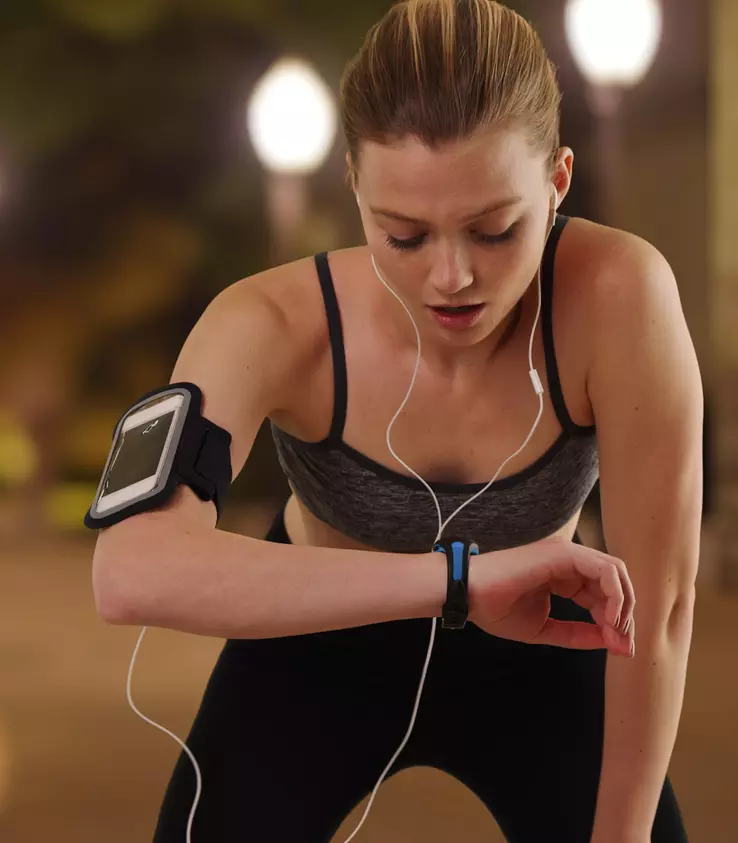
96;478;634;653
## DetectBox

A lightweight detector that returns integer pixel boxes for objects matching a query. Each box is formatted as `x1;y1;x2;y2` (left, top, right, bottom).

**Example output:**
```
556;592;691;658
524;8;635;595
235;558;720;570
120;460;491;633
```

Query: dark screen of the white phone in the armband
103;410;176;495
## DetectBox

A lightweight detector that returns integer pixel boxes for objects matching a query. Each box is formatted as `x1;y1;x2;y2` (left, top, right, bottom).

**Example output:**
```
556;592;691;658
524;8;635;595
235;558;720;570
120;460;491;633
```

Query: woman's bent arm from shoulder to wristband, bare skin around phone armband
92;262;447;638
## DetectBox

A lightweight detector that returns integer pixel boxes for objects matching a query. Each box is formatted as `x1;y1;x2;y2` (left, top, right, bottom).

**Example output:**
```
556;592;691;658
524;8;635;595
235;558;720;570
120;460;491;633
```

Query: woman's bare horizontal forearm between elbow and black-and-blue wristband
96;527;447;638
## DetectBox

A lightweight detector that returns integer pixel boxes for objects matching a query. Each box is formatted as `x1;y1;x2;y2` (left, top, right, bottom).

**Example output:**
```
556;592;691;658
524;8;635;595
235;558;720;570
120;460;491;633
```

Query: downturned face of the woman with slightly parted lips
356;128;572;346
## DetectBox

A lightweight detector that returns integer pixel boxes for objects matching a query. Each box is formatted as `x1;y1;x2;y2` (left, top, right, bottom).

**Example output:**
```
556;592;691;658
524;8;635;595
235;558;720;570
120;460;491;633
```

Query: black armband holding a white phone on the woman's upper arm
84;382;232;530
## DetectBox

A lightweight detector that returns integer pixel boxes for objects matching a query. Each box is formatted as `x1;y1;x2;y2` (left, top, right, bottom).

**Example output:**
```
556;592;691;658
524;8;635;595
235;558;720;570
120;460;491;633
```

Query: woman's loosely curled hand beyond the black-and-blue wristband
469;536;635;656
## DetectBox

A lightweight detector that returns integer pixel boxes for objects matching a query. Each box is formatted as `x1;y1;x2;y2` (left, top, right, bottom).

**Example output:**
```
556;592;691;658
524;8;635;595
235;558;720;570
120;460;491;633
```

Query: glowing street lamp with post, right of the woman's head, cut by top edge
565;0;662;223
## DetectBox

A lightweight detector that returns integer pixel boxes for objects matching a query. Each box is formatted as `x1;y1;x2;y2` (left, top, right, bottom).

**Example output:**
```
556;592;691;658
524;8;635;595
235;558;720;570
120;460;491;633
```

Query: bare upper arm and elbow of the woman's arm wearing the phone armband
92;270;304;618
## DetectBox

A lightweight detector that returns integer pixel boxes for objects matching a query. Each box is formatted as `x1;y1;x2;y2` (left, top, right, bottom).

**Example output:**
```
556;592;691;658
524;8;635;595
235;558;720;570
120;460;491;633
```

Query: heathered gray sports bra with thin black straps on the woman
271;215;599;553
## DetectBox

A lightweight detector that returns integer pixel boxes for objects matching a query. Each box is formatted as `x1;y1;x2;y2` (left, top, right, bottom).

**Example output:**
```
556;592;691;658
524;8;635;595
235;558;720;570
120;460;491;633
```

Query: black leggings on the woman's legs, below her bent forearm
154;504;687;843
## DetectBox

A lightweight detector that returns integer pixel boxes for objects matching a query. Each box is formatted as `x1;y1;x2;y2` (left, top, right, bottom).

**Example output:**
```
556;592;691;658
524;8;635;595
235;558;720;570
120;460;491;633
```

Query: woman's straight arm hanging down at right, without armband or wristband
588;235;703;843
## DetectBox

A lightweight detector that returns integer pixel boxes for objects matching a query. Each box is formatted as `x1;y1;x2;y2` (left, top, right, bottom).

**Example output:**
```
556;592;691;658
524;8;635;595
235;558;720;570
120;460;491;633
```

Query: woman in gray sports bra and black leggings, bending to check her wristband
98;0;701;843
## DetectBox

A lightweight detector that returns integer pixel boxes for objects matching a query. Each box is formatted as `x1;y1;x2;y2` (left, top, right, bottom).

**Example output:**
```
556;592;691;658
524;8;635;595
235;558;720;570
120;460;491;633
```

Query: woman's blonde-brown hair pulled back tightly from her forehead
340;0;561;185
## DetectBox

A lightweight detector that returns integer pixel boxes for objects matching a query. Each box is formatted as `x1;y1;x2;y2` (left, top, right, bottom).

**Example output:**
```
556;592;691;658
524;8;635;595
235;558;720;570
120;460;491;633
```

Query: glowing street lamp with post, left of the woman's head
248;58;336;265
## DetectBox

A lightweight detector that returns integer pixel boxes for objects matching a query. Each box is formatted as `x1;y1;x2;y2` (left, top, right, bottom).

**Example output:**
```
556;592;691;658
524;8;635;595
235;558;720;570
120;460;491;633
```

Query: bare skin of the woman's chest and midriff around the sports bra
269;214;597;550
